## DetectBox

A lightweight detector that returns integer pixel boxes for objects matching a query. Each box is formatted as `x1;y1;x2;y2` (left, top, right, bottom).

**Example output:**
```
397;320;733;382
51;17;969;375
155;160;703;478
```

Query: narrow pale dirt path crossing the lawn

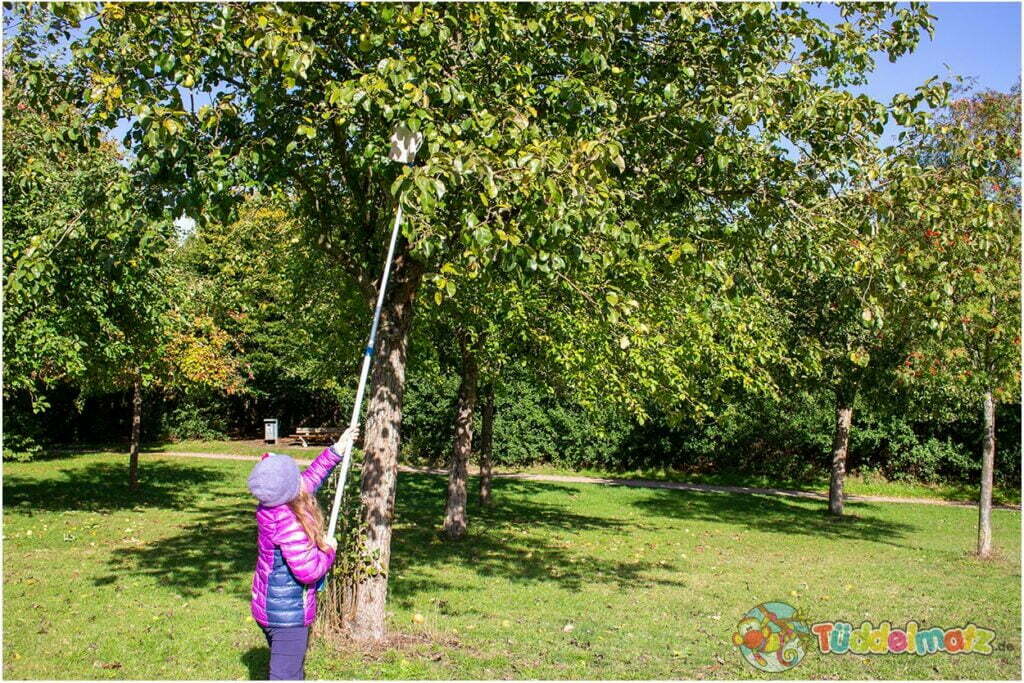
143;451;1021;510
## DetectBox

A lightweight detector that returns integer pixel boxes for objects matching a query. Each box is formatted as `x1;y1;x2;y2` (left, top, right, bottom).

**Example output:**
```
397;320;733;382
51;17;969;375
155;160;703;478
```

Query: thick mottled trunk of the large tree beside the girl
346;254;422;640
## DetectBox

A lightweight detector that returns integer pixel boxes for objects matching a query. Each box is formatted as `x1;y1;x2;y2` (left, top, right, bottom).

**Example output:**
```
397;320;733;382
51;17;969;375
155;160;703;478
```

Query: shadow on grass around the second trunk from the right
633;489;916;545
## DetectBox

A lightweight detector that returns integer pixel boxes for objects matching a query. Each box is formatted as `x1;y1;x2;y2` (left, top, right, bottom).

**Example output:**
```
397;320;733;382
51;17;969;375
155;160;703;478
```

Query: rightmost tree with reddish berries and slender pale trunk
903;85;1021;557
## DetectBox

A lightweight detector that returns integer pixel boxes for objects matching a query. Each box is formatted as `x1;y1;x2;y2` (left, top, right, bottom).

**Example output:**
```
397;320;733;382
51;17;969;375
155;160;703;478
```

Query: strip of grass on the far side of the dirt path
99;440;1021;505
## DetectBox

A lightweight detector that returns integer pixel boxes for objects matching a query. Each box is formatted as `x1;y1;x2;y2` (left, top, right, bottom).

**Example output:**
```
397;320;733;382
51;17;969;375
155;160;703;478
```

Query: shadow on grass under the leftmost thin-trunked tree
3;461;226;515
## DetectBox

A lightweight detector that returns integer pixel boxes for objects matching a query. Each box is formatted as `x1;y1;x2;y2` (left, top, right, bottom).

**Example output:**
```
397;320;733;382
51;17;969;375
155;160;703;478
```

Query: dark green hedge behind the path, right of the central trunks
479;378;1020;491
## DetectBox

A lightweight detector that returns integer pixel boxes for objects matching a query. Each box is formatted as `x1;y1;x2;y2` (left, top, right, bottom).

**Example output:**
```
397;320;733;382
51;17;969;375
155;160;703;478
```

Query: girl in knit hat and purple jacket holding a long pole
249;427;358;680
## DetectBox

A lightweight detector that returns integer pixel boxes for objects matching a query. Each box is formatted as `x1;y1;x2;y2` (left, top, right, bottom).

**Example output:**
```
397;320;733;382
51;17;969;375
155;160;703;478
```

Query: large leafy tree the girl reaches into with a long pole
48;3;930;639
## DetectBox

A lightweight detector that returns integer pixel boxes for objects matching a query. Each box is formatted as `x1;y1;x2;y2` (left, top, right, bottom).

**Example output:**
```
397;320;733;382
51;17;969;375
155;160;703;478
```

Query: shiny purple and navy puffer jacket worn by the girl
252;449;341;627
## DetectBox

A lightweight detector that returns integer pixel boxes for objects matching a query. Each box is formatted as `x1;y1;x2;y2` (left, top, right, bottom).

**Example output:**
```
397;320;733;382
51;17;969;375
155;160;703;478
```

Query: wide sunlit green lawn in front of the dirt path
3;449;1021;679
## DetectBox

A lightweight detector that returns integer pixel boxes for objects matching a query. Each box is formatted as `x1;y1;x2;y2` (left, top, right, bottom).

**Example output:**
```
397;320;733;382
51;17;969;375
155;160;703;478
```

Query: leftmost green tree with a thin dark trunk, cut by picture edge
3;26;170;486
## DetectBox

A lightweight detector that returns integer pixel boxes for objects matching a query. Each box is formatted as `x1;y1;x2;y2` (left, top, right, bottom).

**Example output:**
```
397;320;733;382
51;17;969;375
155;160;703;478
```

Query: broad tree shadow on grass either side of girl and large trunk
90;473;683;604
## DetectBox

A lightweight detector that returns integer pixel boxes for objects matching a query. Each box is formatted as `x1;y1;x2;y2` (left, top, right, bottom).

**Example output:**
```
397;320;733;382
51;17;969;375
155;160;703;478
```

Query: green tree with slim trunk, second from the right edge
769;73;958;515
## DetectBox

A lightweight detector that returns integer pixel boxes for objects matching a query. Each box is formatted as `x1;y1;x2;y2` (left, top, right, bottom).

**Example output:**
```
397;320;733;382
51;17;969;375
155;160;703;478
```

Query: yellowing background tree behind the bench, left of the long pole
165;197;366;430
